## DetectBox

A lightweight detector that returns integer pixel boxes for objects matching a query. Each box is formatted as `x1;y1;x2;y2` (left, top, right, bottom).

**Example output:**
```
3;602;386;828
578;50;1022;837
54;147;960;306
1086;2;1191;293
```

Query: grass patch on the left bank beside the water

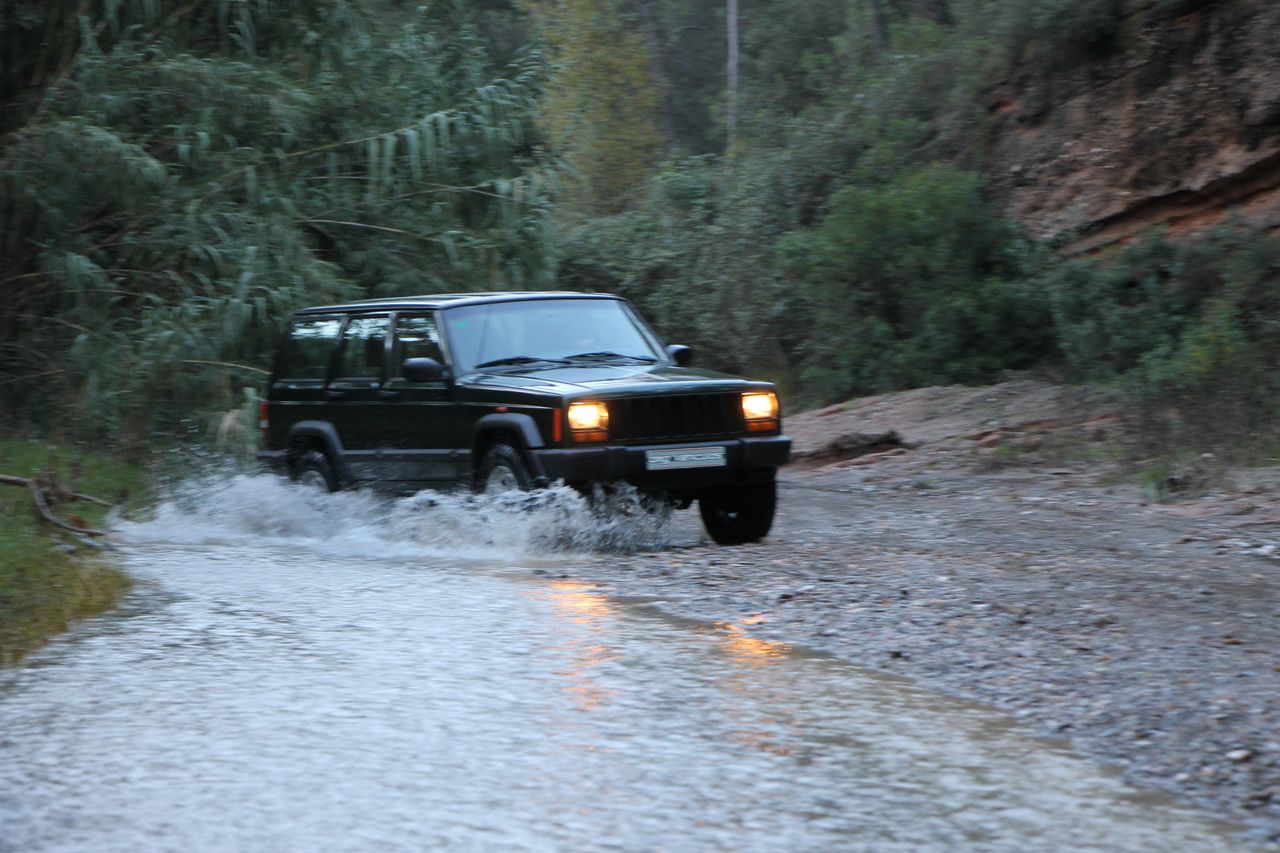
0;438;145;666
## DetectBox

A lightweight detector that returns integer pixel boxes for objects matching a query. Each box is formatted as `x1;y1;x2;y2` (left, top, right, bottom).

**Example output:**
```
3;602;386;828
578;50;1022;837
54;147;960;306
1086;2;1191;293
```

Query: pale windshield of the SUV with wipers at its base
444;298;663;373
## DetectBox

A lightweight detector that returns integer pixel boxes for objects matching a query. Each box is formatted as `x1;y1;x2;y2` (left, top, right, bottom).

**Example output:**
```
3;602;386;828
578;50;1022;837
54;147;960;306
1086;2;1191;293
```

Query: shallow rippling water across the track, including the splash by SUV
0;478;1239;850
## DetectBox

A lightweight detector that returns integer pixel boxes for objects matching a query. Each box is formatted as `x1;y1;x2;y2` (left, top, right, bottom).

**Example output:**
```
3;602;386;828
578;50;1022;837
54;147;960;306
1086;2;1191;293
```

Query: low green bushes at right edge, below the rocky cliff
1044;225;1280;456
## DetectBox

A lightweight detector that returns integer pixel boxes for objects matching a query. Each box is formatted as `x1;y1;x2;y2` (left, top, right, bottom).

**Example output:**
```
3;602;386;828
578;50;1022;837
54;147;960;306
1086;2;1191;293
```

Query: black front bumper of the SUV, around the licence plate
530;435;791;494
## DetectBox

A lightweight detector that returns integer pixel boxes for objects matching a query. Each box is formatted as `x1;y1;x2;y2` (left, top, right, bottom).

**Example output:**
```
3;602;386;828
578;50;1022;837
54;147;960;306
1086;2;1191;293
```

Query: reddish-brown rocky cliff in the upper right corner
988;0;1280;252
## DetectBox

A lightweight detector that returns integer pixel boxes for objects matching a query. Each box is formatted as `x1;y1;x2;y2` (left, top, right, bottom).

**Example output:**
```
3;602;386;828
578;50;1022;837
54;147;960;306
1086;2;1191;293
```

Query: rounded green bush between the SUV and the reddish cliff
778;164;1051;400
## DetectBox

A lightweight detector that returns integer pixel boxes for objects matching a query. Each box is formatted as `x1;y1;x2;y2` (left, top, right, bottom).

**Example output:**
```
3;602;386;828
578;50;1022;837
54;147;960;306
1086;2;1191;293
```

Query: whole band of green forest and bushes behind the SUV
0;0;1280;459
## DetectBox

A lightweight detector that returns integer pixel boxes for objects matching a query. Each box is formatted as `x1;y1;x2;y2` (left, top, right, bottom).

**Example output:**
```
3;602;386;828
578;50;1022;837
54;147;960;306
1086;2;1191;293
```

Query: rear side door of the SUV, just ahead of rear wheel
325;314;390;480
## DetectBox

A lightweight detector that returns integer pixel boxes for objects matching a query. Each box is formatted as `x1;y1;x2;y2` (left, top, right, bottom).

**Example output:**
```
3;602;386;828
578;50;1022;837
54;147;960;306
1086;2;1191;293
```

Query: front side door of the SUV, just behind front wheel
381;311;462;488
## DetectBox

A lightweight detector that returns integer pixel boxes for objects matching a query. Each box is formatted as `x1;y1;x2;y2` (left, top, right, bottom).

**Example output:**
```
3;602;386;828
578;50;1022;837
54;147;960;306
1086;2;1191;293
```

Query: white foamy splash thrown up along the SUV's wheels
115;474;671;558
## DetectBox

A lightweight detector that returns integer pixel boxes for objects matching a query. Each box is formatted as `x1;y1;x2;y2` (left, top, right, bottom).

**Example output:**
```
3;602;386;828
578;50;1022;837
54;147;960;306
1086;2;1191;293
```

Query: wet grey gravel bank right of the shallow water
558;466;1280;849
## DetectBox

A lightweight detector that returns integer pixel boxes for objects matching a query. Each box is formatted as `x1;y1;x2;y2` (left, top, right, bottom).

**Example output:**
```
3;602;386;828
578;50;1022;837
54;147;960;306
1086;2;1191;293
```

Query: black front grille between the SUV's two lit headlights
608;393;745;442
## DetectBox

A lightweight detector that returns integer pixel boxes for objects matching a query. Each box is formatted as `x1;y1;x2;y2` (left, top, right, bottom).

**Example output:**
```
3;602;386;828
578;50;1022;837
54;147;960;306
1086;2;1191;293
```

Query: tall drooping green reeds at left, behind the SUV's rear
0;0;557;441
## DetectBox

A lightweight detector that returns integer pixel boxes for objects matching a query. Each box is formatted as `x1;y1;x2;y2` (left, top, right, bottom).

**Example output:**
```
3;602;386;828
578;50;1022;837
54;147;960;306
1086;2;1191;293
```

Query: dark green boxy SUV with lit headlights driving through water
259;292;791;544
